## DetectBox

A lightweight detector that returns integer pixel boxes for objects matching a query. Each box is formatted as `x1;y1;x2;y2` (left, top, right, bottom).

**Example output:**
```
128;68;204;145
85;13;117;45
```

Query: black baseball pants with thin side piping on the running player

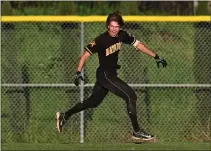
65;68;140;132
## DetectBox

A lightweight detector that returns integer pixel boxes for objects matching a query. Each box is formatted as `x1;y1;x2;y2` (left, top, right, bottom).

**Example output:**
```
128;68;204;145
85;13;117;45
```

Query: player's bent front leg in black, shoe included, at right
101;72;154;140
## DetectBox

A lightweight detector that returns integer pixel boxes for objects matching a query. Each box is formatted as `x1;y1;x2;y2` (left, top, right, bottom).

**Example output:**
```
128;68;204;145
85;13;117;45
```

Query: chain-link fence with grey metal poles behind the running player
1;22;211;143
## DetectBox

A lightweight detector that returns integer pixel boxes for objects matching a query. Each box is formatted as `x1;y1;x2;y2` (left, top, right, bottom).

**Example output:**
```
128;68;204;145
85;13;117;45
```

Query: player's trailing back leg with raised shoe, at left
56;83;108;133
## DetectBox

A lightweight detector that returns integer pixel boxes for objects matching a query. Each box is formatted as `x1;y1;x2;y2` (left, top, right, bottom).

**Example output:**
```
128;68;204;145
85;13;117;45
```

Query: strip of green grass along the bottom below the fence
2;142;211;150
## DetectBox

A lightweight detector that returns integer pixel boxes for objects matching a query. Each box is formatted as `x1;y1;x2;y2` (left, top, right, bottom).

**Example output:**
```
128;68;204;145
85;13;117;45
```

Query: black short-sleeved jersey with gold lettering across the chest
85;30;136;69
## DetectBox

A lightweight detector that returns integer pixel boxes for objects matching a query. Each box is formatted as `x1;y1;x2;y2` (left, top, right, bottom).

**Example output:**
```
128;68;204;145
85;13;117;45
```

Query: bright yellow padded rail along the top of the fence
1;16;211;22
